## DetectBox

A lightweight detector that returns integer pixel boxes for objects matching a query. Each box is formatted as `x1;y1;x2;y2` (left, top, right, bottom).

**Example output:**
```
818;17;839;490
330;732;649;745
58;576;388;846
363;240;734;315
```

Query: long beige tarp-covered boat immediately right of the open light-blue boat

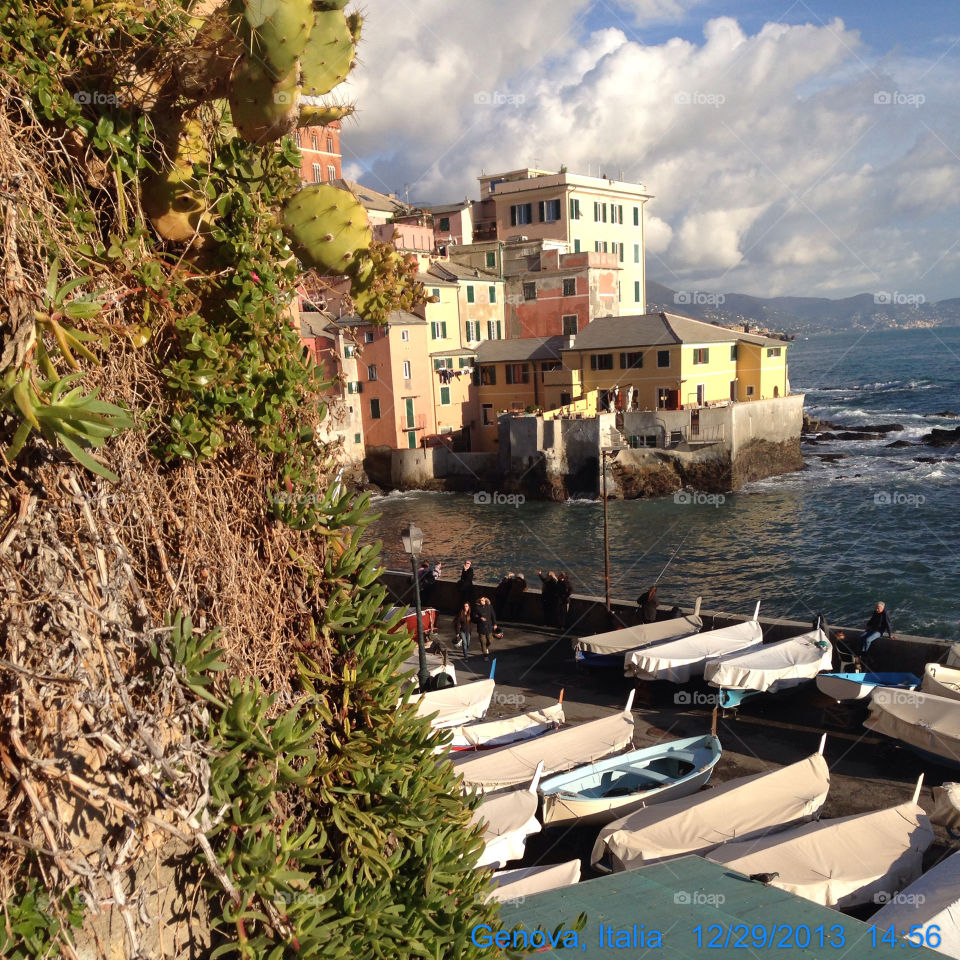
590;753;830;872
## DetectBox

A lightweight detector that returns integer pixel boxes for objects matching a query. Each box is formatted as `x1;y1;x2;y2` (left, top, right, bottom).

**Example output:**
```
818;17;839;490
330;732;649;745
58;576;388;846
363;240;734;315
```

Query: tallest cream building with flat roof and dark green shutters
479;168;651;314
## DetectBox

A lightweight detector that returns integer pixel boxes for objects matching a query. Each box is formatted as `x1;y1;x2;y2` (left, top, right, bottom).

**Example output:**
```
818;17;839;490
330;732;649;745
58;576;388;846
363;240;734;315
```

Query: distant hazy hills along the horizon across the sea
647;280;960;334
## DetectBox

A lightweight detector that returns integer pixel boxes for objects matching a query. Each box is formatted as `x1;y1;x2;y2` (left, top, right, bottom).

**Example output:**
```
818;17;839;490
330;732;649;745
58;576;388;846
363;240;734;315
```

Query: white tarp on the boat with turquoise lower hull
703;630;833;692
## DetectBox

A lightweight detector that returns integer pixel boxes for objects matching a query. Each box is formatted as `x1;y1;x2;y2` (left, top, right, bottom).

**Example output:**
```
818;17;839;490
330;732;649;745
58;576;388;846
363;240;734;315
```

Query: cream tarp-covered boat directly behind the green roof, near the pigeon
707;803;933;908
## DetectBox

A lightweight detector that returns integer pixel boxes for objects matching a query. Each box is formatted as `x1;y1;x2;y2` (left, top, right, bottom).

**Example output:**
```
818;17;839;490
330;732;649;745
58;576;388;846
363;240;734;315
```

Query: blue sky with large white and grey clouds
336;0;960;301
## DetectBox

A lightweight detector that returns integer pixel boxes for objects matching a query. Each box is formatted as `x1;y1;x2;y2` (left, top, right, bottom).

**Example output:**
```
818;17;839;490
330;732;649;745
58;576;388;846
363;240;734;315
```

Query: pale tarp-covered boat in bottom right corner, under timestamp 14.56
870;853;960;958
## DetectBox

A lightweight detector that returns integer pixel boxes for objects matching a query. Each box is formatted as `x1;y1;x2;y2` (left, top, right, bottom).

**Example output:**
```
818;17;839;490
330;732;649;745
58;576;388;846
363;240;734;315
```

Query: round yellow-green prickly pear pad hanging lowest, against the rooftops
283;183;371;275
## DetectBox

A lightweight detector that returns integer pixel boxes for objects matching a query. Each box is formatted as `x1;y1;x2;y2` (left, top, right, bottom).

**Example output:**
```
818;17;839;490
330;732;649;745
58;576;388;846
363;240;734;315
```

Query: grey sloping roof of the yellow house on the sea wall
568;313;783;350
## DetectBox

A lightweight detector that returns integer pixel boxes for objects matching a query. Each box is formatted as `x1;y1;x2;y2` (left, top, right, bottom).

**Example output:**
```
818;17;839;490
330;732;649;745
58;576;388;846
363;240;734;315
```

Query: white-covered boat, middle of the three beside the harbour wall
623;603;763;683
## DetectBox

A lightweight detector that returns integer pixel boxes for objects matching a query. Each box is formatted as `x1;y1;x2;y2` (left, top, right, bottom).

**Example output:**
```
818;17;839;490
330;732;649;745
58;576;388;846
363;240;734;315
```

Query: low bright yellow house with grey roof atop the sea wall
562;313;788;410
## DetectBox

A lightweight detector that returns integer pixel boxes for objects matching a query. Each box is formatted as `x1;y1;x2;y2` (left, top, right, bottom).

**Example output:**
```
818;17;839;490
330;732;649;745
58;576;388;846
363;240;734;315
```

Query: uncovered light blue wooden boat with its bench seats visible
540;736;721;827
